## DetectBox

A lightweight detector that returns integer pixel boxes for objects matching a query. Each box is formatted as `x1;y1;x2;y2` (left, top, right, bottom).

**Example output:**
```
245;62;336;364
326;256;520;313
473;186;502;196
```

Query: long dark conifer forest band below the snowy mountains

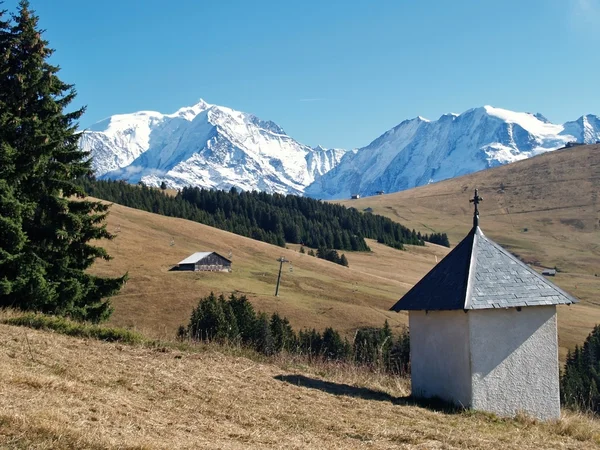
81;178;449;251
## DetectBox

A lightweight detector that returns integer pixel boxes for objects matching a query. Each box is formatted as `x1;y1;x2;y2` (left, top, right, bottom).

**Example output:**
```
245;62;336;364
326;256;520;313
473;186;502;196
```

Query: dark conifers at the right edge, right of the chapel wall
560;325;600;414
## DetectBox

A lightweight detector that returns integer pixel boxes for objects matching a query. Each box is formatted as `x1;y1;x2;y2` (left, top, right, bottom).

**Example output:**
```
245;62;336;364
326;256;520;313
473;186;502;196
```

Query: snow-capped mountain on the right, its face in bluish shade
304;106;600;199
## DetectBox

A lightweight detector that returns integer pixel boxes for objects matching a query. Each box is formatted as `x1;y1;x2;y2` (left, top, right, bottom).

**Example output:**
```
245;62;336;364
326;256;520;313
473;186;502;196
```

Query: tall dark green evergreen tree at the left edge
0;0;125;322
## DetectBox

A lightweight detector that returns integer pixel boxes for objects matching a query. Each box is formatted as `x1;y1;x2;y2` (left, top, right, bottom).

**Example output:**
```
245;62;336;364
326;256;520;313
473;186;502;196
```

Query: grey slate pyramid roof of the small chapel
390;226;578;311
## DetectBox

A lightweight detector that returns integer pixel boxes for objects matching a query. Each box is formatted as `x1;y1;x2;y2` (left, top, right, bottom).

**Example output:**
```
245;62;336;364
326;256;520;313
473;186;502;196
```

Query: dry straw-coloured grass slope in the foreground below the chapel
0;325;600;450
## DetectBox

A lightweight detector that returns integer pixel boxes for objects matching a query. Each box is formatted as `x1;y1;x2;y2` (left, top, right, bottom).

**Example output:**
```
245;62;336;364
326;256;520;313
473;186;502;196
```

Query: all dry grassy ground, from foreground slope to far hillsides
0;146;600;449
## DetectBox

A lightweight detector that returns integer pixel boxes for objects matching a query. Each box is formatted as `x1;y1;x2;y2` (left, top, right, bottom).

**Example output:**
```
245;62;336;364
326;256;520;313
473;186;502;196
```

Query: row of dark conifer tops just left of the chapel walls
177;292;410;374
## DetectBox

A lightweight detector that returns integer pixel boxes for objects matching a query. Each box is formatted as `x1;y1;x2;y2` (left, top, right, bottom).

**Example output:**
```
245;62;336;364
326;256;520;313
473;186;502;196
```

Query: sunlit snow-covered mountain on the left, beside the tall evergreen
80;100;345;194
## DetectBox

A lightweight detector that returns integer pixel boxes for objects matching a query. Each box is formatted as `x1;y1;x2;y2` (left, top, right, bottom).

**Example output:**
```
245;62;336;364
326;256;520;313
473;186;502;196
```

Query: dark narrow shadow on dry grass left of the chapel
274;375;465;414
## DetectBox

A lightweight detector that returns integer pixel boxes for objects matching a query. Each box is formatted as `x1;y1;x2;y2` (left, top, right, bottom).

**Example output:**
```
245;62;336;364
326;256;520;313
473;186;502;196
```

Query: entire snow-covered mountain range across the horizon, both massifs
80;100;600;199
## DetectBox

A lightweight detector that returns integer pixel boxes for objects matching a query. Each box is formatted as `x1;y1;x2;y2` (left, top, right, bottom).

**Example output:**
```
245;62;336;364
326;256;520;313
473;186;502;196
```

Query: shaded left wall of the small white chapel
409;311;471;407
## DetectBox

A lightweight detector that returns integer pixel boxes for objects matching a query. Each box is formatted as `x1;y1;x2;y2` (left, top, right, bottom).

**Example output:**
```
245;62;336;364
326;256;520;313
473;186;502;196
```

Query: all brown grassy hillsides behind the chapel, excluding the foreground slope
94;146;600;358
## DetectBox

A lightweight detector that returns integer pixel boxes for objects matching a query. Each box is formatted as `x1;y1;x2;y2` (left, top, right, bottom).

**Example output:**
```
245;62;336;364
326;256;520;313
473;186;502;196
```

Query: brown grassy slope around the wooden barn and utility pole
88;200;448;338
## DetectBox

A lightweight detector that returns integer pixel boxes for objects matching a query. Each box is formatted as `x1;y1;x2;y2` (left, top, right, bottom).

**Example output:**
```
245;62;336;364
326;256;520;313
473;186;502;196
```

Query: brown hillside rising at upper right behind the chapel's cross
341;145;600;356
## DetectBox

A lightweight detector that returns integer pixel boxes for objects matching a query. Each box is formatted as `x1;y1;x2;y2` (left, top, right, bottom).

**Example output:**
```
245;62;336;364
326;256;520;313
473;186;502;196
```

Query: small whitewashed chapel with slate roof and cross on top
391;188;577;420
